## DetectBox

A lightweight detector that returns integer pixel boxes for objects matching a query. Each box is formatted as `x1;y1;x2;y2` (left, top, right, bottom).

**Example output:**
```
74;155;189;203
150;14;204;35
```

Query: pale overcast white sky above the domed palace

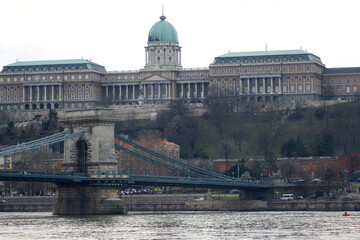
0;0;360;71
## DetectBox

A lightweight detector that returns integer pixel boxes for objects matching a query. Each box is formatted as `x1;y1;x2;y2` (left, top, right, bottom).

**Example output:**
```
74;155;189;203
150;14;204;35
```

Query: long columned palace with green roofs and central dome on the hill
0;16;360;110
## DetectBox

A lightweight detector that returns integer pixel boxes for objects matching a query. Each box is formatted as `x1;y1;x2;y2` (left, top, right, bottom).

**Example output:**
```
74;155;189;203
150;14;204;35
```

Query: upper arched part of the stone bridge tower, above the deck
61;109;117;177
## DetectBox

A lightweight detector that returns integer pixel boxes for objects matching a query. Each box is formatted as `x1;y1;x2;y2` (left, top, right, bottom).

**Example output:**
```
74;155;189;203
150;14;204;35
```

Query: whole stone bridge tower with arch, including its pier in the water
53;108;127;215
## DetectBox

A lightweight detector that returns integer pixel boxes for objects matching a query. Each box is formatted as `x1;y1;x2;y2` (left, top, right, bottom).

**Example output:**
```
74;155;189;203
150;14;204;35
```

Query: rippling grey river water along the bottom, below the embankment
0;212;360;240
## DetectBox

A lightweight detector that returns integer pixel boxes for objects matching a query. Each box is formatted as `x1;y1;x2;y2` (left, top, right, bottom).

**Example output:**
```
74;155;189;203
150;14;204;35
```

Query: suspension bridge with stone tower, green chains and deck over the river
0;109;272;215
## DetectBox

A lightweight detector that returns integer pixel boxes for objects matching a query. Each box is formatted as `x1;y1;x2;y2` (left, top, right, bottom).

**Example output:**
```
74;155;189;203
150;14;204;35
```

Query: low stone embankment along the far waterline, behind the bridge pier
0;194;360;212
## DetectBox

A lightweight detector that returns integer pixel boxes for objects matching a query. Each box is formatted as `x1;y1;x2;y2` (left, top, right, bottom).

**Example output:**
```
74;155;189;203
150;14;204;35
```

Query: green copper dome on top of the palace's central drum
148;16;178;42
